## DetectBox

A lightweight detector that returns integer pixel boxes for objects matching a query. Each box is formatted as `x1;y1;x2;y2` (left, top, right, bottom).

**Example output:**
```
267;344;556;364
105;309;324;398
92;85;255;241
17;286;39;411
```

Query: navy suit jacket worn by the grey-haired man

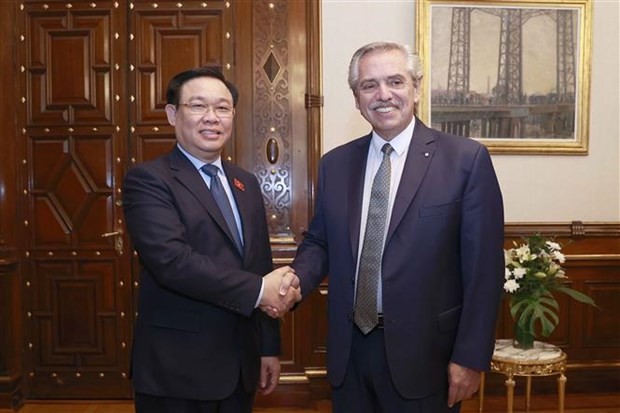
293;119;504;398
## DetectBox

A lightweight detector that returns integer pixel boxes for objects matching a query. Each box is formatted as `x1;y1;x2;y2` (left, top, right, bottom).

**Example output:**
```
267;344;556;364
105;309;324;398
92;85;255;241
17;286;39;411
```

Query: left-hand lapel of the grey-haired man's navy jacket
347;134;372;262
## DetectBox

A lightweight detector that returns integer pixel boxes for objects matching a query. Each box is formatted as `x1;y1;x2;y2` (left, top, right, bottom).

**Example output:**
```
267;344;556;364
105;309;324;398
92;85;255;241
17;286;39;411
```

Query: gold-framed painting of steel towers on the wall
416;0;592;155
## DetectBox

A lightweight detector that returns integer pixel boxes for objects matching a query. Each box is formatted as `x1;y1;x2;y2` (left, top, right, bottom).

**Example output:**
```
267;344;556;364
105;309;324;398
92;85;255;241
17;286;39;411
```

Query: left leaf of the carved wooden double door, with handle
18;1;132;398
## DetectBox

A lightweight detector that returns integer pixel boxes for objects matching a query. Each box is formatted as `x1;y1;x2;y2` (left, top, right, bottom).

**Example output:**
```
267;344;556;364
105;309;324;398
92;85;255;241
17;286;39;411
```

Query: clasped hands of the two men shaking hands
259;266;301;318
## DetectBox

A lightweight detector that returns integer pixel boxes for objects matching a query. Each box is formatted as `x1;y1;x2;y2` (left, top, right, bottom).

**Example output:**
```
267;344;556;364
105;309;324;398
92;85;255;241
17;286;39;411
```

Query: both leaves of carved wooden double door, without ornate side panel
18;1;232;398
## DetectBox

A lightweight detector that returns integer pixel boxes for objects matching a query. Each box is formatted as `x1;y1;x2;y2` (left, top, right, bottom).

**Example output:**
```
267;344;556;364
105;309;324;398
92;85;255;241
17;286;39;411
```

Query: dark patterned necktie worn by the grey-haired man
354;143;394;334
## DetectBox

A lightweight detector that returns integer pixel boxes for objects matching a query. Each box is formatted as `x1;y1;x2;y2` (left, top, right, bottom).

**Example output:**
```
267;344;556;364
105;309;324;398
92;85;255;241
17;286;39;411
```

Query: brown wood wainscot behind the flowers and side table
487;221;620;393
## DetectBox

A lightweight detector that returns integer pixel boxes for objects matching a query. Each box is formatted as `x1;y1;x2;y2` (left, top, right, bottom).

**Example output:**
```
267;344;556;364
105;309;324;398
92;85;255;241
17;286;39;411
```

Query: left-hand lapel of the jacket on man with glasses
170;146;243;256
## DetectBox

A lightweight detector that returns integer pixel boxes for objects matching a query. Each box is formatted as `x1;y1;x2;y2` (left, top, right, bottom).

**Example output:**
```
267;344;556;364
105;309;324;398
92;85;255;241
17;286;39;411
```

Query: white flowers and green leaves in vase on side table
504;234;596;348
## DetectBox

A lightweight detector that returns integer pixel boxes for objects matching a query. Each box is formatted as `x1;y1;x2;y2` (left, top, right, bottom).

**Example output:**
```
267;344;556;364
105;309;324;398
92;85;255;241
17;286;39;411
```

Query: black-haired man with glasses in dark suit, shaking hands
124;68;299;413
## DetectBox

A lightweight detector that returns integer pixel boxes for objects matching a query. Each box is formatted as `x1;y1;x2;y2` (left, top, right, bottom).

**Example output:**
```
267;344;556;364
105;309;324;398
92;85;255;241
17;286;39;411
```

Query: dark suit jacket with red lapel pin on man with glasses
123;147;280;400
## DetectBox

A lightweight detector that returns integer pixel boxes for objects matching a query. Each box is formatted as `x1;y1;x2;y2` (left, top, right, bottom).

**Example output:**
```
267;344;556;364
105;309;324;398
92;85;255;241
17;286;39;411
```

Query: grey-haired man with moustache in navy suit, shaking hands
292;43;504;413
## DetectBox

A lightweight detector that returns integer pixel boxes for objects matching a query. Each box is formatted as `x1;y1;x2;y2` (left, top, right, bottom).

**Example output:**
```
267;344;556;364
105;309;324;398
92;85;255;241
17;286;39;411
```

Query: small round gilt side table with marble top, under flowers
478;339;566;413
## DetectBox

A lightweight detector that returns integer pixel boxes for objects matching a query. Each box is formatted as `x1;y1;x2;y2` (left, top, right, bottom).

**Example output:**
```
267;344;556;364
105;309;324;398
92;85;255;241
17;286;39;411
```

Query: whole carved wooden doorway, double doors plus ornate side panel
16;0;320;398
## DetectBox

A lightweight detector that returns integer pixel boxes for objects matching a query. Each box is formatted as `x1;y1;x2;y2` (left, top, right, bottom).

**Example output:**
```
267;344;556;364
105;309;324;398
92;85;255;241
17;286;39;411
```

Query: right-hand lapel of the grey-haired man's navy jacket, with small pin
385;118;435;241
